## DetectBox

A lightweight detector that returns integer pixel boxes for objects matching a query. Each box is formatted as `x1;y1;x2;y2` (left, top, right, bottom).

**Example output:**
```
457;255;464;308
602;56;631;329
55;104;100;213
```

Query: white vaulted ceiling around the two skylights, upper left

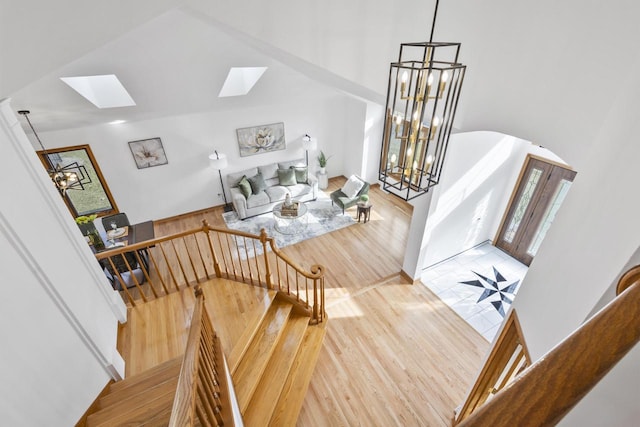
0;0;436;131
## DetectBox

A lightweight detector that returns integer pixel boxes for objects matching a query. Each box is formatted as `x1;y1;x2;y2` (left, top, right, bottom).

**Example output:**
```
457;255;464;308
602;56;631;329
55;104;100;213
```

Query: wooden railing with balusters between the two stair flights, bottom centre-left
169;287;234;427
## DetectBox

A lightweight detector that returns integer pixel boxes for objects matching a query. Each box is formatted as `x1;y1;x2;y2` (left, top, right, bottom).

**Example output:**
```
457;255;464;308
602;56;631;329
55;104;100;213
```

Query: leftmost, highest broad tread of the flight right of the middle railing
233;300;292;412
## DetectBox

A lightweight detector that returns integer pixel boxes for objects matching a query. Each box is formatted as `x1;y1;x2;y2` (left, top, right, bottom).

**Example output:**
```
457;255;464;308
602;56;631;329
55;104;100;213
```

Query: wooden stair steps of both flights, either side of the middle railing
86;292;326;427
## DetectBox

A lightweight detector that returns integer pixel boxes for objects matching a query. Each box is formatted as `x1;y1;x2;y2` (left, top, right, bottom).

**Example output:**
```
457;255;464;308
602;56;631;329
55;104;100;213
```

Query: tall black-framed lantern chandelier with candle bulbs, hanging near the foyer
379;0;466;200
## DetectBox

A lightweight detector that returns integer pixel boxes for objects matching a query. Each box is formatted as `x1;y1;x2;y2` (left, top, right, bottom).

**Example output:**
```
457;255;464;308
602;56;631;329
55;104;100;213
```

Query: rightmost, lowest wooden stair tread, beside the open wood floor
269;317;328;426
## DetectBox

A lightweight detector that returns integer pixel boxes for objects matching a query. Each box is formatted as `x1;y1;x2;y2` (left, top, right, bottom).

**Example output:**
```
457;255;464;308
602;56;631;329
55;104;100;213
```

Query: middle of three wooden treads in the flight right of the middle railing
242;315;309;426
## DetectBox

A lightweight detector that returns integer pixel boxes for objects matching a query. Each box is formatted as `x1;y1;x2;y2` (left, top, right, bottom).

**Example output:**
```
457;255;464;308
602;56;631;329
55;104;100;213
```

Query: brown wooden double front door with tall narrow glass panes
495;156;576;266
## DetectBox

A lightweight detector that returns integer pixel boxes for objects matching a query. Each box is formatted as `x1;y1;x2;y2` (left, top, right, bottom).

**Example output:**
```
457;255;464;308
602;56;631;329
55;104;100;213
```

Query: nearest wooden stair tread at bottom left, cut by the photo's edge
87;377;178;426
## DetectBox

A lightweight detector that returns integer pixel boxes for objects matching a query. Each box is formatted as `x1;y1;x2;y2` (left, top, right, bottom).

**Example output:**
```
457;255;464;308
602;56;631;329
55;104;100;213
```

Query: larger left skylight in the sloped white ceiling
60;74;136;108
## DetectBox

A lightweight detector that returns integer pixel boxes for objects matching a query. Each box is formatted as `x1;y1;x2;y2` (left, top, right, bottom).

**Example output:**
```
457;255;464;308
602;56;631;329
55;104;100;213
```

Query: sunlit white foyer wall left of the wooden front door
421;131;561;268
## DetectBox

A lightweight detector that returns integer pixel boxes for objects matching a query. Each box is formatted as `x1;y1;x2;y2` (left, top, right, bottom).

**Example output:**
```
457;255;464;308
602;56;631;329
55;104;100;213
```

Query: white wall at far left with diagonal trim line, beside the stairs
0;100;126;426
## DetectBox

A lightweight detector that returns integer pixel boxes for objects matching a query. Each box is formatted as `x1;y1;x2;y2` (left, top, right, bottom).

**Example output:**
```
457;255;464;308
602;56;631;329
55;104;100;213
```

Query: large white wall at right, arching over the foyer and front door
430;0;640;426
